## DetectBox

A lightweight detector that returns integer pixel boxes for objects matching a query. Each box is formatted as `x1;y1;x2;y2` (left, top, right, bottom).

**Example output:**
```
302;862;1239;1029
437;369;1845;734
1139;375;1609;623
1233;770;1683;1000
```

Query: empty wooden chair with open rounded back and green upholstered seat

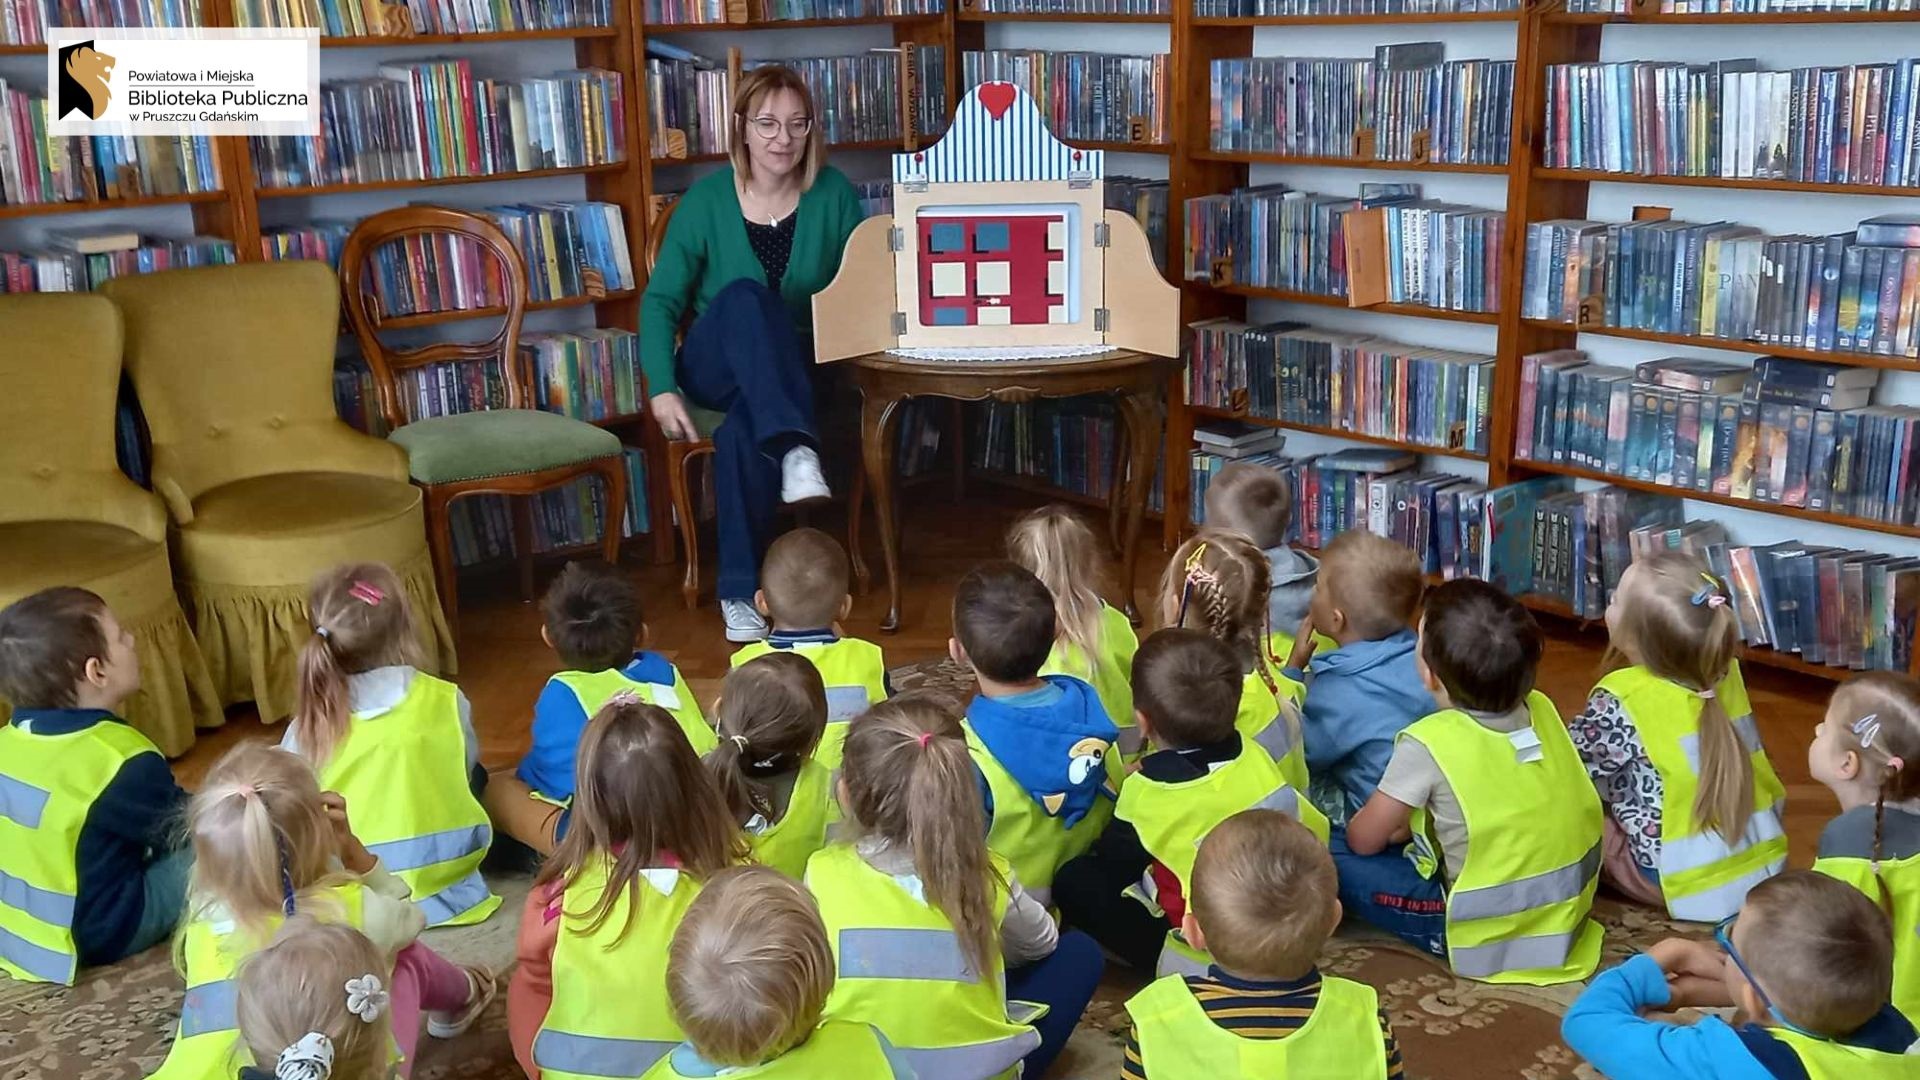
340;206;626;625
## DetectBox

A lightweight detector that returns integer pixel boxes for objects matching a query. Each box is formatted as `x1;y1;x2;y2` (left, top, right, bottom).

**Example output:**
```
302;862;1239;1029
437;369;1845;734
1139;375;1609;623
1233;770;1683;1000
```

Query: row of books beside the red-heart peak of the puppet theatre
960;48;1173;144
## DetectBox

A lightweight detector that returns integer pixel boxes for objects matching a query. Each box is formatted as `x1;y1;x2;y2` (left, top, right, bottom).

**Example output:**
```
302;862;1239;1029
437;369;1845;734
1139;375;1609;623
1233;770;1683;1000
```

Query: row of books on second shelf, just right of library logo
252;58;626;188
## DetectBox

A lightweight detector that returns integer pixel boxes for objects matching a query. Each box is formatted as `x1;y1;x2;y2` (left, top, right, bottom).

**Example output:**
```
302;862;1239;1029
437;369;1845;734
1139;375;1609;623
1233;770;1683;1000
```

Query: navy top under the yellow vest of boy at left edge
12;709;186;967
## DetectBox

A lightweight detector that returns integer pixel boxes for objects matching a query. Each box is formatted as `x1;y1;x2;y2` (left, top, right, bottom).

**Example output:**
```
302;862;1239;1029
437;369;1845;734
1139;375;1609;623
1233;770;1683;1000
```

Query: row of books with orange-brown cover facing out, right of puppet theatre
1185;184;1505;311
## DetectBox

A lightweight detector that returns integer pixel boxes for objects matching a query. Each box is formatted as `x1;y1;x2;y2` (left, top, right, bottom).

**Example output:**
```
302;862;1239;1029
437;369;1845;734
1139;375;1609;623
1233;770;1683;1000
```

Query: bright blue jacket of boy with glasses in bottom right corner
1561;953;1914;1080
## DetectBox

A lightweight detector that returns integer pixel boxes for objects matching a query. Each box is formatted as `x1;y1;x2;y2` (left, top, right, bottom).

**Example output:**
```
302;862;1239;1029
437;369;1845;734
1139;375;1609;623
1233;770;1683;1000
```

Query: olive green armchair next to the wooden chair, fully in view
104;261;455;721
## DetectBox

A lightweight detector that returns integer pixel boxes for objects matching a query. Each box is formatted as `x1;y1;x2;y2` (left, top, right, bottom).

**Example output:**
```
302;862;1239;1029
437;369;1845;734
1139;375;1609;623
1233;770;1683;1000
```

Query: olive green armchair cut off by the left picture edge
0;292;221;757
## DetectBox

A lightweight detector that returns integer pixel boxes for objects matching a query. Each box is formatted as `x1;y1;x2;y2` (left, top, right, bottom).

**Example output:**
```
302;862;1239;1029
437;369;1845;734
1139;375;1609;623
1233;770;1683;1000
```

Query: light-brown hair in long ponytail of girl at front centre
843;692;1006;974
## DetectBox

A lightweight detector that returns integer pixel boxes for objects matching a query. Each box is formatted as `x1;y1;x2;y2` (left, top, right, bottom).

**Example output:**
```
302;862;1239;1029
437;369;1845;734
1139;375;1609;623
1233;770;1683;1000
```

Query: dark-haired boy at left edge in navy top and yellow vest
0;586;194;986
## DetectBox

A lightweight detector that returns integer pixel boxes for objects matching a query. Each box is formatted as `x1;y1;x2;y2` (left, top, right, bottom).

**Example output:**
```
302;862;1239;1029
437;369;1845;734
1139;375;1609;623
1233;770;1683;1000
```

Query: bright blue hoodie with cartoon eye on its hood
966;675;1119;828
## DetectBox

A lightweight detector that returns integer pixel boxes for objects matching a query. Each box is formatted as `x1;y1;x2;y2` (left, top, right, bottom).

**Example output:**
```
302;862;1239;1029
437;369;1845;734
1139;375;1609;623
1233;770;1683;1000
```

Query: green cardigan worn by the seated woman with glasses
639;165;862;394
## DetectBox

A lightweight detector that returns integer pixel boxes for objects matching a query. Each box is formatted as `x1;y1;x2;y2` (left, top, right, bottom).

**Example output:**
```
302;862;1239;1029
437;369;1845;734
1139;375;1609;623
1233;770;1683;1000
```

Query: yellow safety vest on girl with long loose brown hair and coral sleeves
534;855;701;1080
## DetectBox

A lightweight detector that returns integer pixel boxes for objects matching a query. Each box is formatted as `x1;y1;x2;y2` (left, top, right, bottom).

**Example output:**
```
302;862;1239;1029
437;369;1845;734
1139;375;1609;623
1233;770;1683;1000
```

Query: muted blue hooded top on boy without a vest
1286;630;1438;821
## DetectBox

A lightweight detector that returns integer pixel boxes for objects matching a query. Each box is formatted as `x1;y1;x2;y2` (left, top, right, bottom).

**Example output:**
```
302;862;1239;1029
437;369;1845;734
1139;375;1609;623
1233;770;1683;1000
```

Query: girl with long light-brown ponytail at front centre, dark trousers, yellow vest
806;694;1104;1080
